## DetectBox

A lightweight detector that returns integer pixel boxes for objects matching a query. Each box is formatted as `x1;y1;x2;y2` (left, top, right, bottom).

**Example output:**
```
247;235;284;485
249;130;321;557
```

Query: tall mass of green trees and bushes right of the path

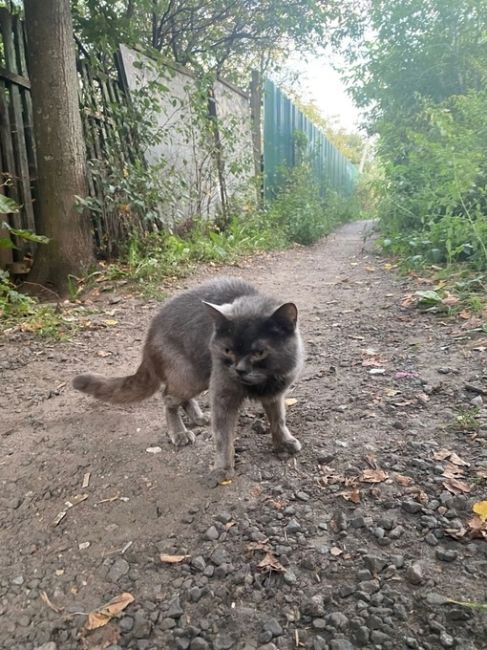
347;0;487;271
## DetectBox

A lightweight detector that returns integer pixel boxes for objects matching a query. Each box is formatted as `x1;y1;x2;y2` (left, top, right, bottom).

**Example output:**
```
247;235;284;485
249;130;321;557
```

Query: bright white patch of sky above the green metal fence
284;55;361;131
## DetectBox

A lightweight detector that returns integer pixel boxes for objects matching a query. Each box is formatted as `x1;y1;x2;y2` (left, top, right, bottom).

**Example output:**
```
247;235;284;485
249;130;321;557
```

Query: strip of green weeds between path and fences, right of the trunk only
100;159;359;293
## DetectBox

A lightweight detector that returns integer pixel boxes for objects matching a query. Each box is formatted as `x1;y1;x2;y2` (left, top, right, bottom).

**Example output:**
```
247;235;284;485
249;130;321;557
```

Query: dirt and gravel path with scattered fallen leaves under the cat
0;223;487;650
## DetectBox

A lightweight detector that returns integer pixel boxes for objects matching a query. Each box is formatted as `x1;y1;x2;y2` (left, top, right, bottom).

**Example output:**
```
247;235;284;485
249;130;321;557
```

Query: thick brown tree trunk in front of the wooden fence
24;0;94;295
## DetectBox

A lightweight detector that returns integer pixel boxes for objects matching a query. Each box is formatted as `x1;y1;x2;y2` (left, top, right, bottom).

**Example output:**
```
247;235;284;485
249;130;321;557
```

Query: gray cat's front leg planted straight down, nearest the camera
210;377;243;484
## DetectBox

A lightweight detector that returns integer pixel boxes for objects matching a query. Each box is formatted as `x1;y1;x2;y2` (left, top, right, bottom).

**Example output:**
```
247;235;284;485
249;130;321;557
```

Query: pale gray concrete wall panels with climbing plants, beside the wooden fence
120;46;253;223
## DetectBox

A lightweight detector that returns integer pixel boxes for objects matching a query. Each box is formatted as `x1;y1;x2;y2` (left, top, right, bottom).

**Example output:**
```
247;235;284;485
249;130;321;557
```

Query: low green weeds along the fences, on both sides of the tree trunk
0;163;359;339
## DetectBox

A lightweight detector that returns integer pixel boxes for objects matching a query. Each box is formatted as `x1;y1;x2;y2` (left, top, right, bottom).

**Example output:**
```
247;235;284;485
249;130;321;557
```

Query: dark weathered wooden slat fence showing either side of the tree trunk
0;8;143;275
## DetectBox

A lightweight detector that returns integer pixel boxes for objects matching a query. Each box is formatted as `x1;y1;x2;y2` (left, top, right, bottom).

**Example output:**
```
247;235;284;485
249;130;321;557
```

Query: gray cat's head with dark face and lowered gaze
205;296;299;386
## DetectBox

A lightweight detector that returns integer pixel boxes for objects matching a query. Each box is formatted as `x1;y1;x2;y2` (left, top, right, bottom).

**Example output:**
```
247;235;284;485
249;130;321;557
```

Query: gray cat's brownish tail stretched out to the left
73;358;161;404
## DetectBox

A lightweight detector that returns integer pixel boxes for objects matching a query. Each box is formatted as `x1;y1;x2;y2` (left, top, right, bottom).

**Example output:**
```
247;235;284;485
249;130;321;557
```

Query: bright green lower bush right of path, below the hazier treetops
379;91;487;269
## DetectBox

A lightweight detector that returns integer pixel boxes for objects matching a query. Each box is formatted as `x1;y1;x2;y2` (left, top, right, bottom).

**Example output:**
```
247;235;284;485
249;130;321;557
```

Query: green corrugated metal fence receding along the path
263;79;358;199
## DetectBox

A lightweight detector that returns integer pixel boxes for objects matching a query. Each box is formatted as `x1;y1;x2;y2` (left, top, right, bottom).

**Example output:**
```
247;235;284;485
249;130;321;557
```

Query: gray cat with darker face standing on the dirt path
73;278;304;481
